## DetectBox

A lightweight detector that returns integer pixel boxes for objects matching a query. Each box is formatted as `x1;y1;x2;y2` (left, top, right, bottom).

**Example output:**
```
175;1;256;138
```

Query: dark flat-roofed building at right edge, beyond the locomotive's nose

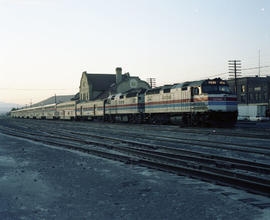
227;76;270;120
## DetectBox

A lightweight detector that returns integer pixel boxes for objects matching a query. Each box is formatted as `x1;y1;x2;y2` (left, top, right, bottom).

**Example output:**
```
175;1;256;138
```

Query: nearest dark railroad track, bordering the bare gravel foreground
0;121;270;196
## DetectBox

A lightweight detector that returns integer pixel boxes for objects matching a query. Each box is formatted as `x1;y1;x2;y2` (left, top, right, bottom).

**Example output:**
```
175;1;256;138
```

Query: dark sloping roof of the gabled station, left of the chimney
86;73;116;91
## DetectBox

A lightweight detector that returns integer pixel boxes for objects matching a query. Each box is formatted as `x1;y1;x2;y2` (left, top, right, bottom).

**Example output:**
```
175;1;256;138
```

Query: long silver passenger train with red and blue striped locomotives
11;78;238;127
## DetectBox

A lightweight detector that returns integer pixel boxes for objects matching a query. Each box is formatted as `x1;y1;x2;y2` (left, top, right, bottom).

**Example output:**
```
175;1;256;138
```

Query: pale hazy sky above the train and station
0;0;270;104
